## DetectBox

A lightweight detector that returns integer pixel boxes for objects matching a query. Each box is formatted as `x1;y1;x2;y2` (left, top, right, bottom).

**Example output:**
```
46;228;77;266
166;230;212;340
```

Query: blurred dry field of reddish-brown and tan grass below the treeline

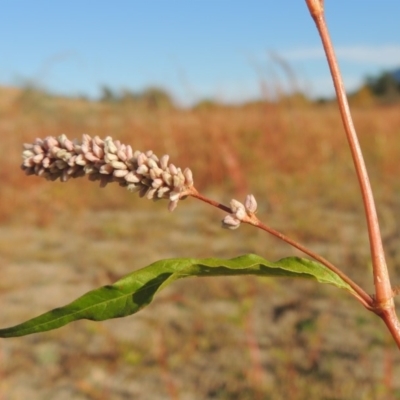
0;88;400;400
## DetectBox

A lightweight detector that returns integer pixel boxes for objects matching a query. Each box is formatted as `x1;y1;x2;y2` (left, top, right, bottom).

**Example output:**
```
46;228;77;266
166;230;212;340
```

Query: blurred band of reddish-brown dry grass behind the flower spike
0;91;400;218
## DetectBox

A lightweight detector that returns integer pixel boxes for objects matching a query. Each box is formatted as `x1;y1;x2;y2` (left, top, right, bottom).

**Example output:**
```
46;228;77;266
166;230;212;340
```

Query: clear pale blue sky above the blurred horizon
0;0;400;104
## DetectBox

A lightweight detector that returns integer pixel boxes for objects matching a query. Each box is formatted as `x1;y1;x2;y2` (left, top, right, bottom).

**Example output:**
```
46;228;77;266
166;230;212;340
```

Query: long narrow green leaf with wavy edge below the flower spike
0;254;353;338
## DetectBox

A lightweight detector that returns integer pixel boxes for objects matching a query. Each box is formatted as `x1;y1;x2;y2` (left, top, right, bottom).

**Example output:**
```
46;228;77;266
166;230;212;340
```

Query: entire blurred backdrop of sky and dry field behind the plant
0;0;400;400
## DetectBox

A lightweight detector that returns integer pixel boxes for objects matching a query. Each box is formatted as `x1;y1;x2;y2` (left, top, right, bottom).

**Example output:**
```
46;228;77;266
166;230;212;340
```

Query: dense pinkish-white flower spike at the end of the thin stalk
21;134;193;211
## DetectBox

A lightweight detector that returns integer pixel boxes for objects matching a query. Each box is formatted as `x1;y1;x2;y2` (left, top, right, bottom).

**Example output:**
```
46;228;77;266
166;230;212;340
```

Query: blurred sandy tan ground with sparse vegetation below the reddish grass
0;200;400;400
